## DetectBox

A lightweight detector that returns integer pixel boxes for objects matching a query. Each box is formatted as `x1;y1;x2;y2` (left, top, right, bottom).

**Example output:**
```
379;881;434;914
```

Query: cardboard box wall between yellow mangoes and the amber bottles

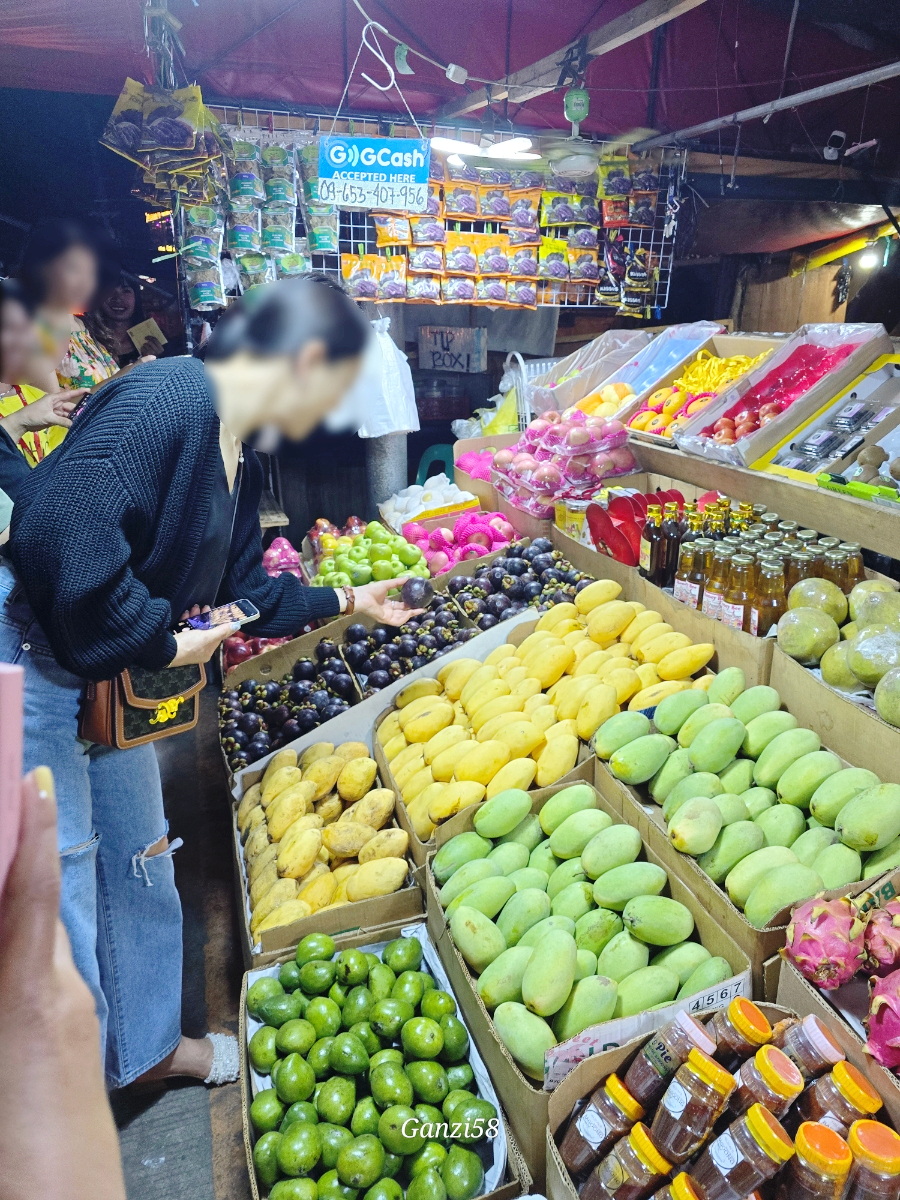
551;528;777;691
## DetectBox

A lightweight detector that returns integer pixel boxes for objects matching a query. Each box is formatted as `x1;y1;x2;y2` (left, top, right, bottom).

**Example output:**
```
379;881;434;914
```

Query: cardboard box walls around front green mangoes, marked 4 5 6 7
425;782;751;1188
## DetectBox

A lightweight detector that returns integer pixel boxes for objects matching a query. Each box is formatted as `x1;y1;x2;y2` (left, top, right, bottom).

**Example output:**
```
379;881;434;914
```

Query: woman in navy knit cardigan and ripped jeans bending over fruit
0;280;422;1088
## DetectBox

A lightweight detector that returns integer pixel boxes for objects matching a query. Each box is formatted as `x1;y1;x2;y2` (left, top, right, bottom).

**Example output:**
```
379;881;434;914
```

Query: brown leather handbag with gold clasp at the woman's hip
78;664;206;750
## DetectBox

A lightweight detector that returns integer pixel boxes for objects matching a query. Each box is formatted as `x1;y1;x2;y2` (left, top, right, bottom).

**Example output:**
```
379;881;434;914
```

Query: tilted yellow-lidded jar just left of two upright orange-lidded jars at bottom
688;1104;793;1200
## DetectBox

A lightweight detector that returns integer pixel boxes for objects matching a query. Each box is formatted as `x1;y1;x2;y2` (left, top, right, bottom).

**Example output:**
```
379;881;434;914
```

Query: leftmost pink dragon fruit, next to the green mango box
781;896;865;991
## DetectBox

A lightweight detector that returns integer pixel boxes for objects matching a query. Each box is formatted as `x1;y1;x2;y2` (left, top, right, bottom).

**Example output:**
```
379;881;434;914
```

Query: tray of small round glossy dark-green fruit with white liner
240;922;527;1200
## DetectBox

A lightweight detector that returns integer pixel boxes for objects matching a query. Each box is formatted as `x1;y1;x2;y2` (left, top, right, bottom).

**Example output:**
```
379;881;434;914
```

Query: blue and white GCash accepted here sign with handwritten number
319;137;431;212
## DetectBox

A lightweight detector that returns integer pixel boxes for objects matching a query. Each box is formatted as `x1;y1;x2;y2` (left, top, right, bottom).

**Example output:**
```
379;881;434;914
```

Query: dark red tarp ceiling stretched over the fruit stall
0;0;900;169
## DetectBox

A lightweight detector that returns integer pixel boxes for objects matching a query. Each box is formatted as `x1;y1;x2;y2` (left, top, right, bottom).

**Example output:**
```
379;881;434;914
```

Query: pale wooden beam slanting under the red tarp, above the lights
436;0;706;121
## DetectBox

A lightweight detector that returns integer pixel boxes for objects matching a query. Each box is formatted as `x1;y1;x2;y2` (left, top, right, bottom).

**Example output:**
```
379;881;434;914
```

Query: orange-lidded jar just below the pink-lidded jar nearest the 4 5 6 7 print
650;1050;734;1163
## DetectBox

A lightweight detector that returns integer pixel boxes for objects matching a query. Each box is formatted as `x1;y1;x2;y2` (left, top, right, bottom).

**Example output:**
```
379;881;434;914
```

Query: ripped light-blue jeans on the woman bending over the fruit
0;559;181;1088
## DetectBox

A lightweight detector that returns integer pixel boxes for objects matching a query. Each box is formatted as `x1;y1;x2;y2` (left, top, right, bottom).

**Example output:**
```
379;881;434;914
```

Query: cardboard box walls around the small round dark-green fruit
238;922;532;1200
